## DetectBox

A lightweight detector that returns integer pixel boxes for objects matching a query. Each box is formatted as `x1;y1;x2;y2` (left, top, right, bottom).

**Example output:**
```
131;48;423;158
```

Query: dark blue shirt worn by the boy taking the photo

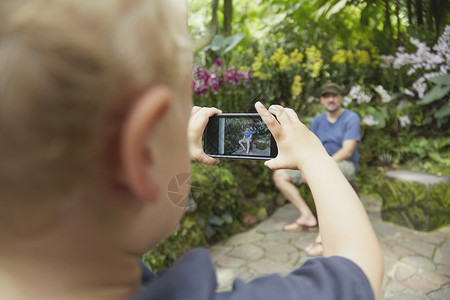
131;248;374;300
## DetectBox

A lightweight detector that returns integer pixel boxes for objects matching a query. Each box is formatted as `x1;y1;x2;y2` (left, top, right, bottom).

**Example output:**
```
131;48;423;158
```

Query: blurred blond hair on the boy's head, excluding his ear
0;0;191;229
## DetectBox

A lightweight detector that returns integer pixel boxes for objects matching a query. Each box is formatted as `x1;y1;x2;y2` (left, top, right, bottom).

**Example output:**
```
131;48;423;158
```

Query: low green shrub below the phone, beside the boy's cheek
143;163;243;271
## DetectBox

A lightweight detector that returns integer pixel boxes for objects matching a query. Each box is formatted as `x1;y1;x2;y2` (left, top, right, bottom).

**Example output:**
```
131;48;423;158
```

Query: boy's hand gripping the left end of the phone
188;106;222;166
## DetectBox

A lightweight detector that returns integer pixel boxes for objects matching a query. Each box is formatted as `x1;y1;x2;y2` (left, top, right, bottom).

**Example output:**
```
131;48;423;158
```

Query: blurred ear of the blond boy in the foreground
121;86;172;202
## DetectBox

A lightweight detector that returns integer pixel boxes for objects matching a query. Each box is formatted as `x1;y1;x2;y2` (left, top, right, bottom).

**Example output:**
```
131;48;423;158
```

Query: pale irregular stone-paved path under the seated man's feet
210;195;450;300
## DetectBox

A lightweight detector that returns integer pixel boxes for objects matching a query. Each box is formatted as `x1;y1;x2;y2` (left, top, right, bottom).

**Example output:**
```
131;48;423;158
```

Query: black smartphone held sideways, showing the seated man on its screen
203;113;278;160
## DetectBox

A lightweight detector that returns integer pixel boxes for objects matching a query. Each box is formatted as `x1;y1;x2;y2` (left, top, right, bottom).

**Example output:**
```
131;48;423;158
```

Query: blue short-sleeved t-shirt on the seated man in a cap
311;109;361;170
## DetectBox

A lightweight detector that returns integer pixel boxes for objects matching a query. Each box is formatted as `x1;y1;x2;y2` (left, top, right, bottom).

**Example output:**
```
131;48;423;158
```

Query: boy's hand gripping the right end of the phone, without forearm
255;102;328;170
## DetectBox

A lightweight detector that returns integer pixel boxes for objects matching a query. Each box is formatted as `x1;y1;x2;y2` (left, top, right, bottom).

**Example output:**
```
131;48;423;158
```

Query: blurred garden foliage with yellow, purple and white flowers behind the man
145;0;450;269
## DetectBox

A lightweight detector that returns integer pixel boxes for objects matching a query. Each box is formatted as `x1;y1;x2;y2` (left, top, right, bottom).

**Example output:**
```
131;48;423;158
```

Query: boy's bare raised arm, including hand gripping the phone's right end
255;102;384;298
